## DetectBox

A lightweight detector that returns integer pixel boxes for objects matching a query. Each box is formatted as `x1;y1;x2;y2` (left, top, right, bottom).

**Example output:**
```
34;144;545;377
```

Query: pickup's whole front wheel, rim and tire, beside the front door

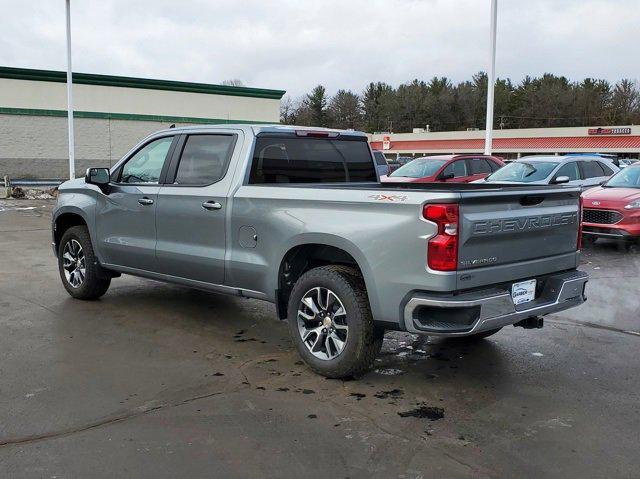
58;226;111;299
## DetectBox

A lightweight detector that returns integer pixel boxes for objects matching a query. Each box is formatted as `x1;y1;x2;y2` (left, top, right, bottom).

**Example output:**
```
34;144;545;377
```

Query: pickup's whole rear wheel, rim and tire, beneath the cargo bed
287;266;384;378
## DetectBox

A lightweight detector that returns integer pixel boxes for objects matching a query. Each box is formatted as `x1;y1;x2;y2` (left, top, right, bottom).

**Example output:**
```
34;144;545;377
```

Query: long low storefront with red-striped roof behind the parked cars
371;125;640;159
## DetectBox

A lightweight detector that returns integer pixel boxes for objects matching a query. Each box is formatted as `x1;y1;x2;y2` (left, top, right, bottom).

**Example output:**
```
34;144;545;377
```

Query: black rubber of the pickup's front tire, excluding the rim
58;226;111;299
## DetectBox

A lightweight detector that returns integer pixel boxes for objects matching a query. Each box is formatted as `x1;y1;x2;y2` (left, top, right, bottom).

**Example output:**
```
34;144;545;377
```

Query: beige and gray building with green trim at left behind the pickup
0;67;285;178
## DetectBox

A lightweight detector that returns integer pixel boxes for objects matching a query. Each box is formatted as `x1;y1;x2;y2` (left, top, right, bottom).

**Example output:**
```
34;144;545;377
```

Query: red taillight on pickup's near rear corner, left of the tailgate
422;203;459;271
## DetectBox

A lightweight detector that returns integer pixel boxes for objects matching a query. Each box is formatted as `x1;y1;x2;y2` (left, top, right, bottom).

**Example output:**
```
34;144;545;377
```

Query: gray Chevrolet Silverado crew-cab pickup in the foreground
53;125;587;378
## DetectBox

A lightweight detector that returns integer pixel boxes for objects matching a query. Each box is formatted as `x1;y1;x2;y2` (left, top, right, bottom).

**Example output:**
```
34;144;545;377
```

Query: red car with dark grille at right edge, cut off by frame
582;163;640;240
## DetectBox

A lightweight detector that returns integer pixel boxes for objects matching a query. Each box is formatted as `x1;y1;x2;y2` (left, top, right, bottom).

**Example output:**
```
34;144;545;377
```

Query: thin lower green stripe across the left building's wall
0;107;278;125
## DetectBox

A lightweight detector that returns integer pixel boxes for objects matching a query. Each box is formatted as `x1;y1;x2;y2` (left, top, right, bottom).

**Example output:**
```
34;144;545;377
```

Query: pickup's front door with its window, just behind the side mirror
95;136;174;271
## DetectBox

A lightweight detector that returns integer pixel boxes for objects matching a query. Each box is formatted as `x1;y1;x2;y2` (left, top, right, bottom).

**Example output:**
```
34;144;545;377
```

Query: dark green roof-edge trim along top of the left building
0;66;286;100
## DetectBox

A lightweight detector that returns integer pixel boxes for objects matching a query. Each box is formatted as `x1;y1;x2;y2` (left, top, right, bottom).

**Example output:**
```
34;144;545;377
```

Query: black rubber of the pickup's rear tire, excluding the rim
287;265;384;379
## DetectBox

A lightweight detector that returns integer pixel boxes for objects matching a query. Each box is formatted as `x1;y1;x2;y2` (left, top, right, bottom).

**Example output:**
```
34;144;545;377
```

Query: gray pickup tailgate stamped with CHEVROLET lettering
458;186;580;289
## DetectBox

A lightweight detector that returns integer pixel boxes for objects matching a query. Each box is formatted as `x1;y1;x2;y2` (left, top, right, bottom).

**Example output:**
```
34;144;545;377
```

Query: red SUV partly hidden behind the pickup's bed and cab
380;155;504;183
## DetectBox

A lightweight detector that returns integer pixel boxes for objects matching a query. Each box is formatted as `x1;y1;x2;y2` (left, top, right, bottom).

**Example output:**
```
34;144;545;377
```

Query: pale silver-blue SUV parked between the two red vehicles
481;155;620;189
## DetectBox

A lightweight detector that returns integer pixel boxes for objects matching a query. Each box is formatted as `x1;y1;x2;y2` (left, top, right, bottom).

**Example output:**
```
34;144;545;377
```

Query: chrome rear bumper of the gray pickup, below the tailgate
404;270;589;336
